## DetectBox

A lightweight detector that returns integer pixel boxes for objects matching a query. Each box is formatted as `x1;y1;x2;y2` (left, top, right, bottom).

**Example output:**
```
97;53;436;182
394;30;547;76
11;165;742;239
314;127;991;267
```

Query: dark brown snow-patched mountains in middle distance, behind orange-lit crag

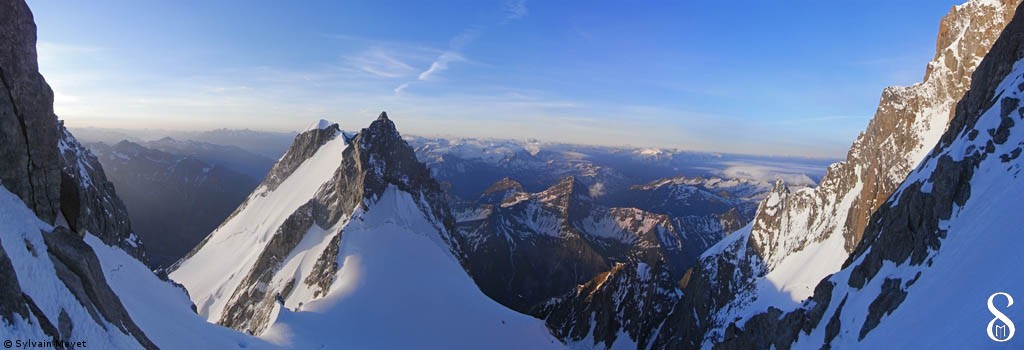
456;177;684;313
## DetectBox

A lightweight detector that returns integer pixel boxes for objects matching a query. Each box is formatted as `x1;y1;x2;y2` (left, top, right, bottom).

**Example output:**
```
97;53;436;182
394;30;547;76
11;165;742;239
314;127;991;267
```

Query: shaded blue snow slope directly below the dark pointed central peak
263;186;563;349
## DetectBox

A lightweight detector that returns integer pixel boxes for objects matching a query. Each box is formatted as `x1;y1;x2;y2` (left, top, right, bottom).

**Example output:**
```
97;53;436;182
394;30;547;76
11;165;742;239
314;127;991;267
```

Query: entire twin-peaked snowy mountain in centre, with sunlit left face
171;114;558;348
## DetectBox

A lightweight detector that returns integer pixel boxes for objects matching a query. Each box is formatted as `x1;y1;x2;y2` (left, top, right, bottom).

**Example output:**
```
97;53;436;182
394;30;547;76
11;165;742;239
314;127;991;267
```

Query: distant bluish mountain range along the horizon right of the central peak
407;136;833;200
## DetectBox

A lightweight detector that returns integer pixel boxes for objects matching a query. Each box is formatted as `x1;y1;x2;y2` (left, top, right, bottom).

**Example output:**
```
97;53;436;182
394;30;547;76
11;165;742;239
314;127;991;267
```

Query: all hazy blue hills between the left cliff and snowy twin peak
73;133;280;266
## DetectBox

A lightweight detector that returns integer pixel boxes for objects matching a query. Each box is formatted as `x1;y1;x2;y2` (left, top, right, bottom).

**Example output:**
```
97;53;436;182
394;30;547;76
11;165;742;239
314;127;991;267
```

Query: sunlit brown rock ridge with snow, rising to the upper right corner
657;0;1017;347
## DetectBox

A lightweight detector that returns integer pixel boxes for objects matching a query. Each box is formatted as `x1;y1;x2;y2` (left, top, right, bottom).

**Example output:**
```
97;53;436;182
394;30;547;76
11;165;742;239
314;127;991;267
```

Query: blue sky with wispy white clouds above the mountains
29;0;957;158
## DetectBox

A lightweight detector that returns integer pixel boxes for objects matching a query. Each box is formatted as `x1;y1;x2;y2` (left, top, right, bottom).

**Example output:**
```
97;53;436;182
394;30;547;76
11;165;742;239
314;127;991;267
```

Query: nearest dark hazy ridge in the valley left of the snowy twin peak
86;141;258;266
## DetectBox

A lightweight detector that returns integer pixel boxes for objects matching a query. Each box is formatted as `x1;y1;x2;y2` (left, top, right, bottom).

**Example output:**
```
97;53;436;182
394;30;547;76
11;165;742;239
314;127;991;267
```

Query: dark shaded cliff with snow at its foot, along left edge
0;1;169;348
